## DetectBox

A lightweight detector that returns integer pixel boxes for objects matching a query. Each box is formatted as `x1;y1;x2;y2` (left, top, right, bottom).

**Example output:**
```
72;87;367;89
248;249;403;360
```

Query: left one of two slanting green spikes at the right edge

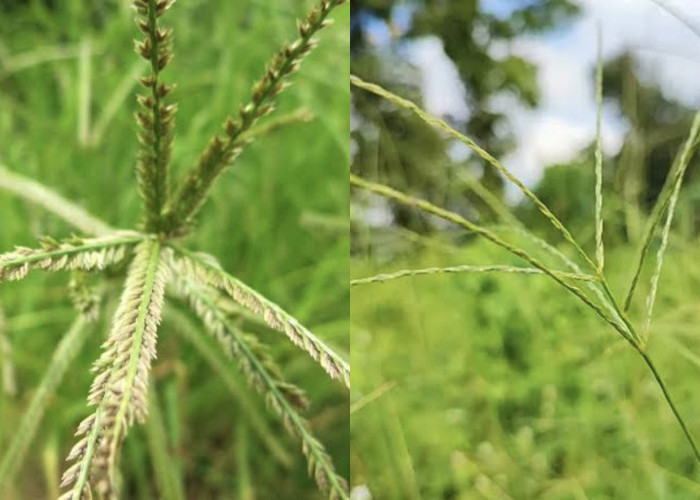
623;111;700;312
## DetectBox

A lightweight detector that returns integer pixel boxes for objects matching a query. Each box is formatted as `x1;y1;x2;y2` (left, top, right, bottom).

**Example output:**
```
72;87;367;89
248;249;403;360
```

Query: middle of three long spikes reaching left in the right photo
350;174;636;345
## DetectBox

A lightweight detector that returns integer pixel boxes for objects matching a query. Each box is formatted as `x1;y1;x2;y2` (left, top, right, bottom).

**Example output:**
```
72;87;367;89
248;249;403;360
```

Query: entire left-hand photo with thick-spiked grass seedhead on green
0;0;350;500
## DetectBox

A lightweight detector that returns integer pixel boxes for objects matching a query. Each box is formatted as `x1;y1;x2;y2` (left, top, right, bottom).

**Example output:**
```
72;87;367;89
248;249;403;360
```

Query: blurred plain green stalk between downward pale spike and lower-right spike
165;307;292;469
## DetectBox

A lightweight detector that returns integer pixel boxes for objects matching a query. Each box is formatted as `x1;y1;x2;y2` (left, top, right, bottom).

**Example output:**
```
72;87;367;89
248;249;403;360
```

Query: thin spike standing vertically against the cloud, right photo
595;26;605;276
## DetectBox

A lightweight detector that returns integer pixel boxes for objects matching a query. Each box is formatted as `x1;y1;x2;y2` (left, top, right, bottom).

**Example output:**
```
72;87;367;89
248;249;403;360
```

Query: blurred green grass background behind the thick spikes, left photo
0;0;349;500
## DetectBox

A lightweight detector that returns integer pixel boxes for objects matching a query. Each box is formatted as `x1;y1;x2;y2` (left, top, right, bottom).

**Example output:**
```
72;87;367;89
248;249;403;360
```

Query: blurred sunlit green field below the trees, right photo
351;231;700;499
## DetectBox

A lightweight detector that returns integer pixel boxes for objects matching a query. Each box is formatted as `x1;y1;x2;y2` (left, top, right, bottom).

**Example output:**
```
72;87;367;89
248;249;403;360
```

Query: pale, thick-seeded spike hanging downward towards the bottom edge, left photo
61;240;169;500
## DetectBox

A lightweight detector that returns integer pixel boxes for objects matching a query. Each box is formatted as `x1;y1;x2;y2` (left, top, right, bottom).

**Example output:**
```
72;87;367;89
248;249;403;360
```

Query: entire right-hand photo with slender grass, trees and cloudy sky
350;0;700;500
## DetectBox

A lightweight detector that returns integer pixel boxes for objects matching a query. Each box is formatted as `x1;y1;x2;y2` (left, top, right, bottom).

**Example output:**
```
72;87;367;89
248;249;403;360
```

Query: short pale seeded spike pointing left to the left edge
0;232;143;283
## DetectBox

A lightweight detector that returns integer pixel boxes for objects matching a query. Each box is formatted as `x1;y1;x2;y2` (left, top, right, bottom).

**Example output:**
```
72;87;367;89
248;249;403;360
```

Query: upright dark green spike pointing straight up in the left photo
133;0;177;232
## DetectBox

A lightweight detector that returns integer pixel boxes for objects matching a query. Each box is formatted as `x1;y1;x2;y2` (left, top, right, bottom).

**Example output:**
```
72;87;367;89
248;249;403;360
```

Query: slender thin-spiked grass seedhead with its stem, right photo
350;64;700;462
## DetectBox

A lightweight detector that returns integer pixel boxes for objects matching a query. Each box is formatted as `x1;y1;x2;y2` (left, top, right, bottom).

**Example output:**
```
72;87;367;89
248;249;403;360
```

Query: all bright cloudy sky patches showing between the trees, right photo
352;0;700;191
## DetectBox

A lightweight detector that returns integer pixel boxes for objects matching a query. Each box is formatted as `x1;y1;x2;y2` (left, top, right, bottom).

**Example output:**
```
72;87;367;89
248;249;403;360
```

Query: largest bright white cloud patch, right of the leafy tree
495;0;700;188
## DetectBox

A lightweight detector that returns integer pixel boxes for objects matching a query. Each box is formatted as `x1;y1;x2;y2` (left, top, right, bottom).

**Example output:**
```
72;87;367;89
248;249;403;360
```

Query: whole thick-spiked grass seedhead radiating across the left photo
0;0;350;500
